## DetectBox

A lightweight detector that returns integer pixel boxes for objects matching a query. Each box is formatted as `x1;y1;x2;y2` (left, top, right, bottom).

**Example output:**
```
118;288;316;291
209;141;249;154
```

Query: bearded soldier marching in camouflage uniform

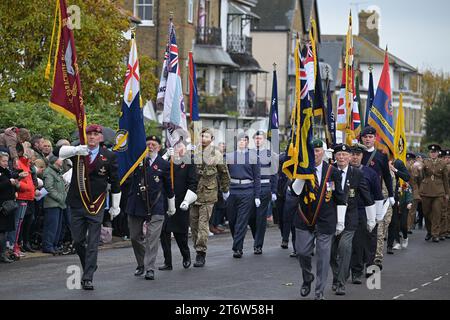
190;145;230;253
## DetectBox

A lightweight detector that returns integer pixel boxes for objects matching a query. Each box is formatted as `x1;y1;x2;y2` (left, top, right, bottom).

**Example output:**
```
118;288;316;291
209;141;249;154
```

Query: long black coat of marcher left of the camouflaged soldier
163;164;198;233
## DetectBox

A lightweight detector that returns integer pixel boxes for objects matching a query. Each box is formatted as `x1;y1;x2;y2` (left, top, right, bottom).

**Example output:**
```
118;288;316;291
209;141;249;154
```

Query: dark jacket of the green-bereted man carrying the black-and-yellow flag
294;162;345;234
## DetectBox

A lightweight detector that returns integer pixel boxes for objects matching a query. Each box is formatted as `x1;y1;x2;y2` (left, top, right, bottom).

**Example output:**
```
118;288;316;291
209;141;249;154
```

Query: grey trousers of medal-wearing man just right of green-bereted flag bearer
330;230;355;286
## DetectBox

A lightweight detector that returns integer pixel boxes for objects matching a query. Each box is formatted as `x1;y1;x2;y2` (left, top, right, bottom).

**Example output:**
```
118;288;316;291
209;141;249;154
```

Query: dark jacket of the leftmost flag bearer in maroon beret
66;148;120;212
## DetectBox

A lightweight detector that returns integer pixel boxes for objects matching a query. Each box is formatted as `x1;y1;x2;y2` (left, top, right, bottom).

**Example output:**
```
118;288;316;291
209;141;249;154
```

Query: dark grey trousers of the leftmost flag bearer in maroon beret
71;207;104;281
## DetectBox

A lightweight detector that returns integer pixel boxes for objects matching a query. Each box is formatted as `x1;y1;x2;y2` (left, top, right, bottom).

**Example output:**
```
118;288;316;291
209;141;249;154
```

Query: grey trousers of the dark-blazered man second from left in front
128;215;164;271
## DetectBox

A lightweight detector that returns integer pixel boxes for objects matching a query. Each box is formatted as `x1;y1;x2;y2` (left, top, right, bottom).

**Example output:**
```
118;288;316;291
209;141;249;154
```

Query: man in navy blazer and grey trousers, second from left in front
125;136;175;280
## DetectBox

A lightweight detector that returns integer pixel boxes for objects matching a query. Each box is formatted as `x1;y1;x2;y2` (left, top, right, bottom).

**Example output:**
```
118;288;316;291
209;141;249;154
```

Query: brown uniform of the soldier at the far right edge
420;159;449;238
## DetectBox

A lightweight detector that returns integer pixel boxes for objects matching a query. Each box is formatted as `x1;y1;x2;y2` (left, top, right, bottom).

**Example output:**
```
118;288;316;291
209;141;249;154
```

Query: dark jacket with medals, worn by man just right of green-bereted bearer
344;166;375;231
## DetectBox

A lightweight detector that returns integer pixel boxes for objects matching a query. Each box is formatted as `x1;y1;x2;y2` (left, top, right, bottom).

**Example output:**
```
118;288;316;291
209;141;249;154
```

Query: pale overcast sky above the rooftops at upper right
317;0;450;73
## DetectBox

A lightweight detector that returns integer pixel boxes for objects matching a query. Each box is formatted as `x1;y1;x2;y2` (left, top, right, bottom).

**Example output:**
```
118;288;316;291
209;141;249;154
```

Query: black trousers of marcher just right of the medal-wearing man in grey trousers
350;218;377;276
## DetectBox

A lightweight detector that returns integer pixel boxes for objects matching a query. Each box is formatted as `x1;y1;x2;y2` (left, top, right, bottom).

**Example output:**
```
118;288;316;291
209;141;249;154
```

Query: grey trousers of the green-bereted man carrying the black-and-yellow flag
295;228;333;295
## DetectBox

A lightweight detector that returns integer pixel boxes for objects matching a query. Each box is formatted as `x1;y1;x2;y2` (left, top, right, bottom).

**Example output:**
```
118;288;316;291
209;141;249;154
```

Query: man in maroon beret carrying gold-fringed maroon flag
46;0;121;290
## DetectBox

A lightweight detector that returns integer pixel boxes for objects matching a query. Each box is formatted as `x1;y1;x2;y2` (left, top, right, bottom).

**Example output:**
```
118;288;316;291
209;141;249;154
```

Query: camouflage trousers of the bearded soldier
190;203;214;252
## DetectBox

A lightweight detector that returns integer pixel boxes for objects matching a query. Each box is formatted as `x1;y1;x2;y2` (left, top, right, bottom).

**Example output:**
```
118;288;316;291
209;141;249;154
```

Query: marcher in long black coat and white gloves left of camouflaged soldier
158;142;198;270
